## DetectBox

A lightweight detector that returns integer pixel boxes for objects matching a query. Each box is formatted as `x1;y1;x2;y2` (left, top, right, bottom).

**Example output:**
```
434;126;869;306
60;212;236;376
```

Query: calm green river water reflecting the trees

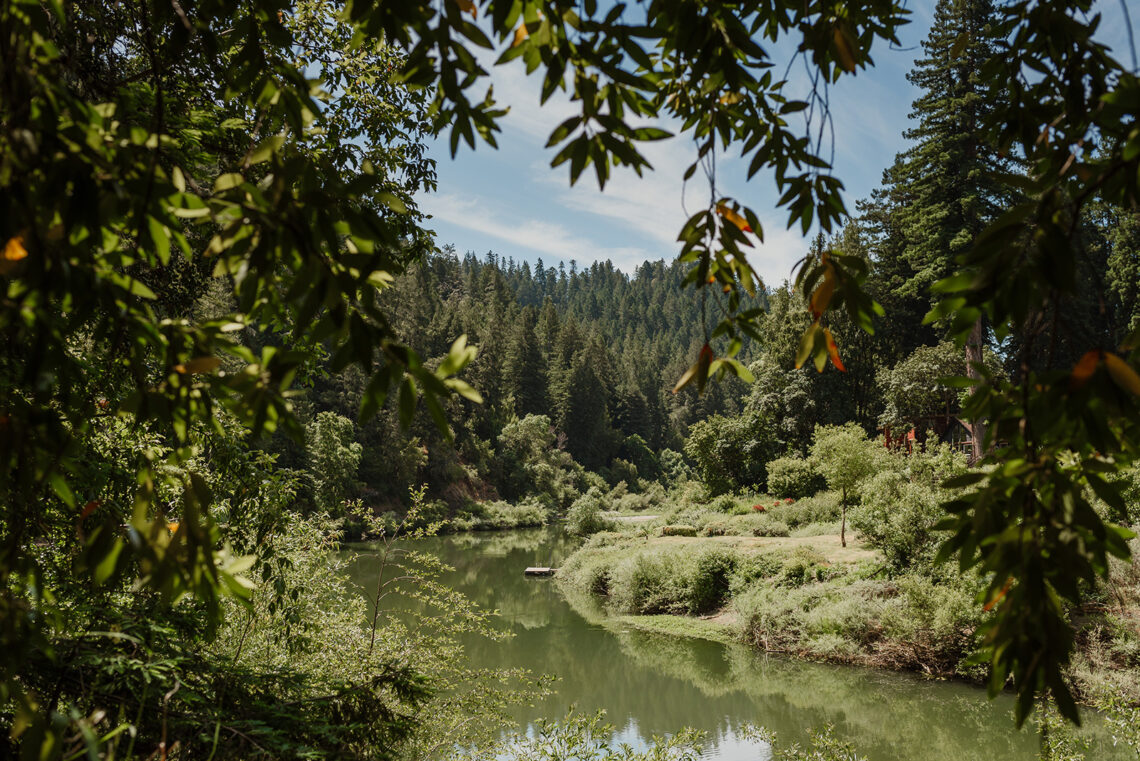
350;529;1126;761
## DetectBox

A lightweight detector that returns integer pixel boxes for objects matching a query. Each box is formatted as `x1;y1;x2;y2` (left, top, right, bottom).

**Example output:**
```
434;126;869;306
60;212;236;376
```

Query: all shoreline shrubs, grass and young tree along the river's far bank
362;420;1140;724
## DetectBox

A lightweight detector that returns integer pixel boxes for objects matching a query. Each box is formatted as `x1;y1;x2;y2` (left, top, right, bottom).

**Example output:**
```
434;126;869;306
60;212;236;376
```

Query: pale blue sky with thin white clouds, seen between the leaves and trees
420;0;1137;286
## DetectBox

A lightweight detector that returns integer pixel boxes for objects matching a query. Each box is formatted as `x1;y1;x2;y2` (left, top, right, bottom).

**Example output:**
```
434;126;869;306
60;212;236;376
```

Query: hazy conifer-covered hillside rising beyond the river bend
278;247;767;505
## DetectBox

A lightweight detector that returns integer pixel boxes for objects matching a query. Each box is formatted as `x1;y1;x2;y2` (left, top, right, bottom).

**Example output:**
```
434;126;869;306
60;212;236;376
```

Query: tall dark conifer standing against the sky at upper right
871;0;1012;457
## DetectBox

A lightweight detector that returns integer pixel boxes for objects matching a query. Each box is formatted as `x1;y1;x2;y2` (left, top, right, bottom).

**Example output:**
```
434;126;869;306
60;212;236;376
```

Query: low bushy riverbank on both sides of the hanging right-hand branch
557;510;1140;702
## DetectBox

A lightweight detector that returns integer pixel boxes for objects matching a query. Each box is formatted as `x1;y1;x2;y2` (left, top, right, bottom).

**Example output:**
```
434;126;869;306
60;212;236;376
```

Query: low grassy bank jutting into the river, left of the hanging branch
559;524;979;676
